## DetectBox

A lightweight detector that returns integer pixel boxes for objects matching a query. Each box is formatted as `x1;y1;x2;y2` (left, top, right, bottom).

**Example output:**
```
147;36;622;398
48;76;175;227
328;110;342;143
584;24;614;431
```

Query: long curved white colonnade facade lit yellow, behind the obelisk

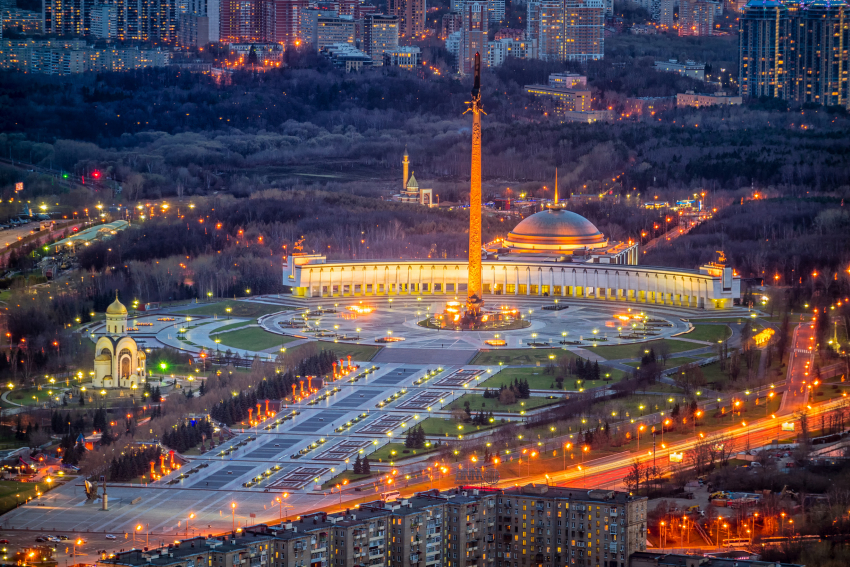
283;257;741;309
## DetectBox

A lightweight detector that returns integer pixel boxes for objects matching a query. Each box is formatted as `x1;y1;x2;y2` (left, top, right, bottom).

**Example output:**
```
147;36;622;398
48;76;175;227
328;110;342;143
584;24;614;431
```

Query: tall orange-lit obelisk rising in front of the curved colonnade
466;53;484;319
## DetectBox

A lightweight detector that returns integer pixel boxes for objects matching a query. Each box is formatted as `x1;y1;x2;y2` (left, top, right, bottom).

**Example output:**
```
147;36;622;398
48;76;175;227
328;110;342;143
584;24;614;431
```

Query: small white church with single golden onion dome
92;292;147;389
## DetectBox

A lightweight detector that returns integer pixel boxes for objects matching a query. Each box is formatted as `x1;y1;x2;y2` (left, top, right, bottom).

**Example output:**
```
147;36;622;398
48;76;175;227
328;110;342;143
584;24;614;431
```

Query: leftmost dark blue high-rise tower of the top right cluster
738;0;789;98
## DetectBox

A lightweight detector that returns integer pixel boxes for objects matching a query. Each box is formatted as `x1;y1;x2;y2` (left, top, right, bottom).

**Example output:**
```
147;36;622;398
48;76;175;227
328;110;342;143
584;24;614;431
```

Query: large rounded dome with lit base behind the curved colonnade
504;209;608;253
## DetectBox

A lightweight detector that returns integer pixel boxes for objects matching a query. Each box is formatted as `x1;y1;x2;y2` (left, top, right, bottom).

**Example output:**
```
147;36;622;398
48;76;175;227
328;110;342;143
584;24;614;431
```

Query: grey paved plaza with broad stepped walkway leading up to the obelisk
3;296;745;545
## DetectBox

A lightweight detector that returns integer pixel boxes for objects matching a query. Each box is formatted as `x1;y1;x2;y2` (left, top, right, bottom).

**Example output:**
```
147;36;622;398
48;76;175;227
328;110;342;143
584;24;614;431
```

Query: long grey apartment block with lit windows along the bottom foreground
97;485;647;567
